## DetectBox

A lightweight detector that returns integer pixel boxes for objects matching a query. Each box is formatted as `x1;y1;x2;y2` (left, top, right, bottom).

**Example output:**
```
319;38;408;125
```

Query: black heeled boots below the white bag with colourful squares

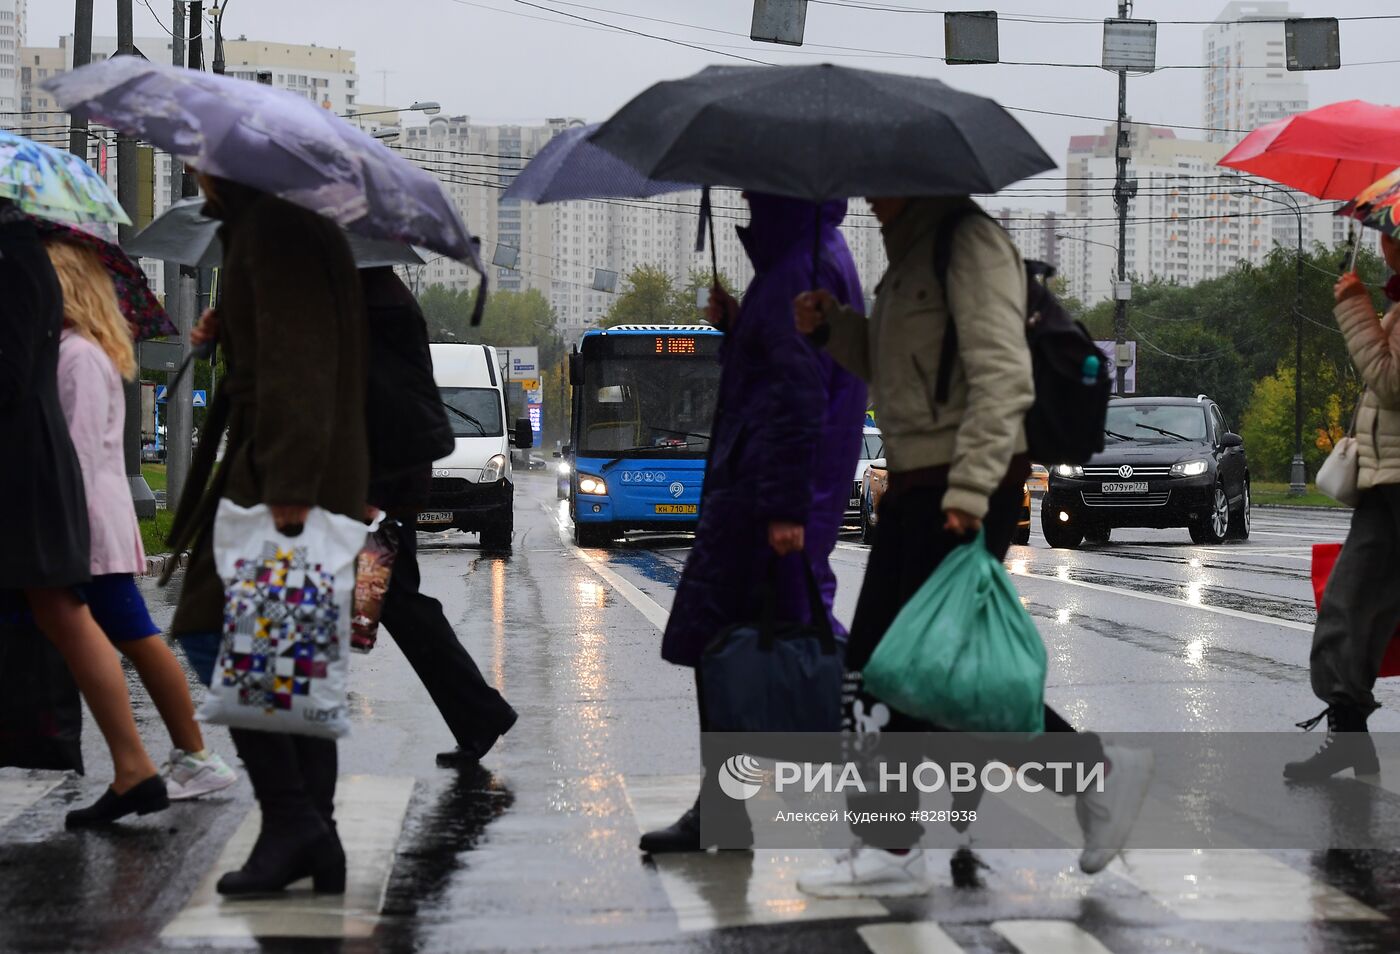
217;728;346;897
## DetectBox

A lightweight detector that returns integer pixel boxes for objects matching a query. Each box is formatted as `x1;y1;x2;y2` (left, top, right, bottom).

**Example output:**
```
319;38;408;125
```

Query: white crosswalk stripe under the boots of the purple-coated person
623;775;889;932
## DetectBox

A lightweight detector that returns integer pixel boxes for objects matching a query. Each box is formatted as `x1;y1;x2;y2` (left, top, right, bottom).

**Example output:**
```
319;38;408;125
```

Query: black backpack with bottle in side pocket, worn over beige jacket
934;206;1113;465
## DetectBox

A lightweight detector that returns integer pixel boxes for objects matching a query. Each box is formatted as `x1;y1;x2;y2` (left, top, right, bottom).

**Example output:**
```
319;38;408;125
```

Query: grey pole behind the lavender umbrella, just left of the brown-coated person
165;0;199;513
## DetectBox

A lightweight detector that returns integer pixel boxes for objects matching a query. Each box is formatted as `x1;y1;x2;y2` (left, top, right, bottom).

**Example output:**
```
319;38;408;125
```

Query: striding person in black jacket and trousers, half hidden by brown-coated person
360;268;517;768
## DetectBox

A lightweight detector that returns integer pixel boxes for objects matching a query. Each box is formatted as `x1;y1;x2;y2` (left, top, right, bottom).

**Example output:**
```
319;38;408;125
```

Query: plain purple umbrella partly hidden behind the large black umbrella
501;123;700;202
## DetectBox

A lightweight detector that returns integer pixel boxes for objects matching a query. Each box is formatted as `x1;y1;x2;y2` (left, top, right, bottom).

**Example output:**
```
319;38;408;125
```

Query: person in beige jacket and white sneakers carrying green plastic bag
794;196;1151;898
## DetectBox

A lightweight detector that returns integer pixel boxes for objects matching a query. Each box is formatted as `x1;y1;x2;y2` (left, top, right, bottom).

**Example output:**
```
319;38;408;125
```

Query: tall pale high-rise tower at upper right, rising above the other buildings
1201;1;1308;143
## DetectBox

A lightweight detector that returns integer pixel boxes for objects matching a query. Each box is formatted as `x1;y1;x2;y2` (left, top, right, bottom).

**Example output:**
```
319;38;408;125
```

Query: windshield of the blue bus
575;353;720;458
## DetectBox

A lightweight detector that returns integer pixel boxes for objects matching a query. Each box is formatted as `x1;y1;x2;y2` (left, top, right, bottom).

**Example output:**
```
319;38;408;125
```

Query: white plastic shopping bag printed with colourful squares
199;500;367;738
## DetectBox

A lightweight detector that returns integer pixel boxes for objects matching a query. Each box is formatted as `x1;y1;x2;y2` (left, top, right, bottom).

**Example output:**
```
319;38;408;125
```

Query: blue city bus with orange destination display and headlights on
568;325;724;546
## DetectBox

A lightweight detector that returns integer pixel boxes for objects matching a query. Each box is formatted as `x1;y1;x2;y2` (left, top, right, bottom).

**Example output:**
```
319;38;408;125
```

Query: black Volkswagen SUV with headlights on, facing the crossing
1040;394;1249;549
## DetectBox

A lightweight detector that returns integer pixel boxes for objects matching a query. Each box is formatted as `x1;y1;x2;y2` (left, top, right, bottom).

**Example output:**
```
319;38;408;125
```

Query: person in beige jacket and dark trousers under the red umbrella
1284;235;1400;780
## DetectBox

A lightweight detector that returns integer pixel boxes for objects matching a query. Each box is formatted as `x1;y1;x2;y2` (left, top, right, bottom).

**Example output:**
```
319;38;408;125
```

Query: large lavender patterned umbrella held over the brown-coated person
43;56;484;271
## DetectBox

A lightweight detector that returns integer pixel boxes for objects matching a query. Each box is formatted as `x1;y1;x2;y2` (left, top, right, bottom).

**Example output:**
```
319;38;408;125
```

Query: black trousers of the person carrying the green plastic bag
847;473;1103;848
